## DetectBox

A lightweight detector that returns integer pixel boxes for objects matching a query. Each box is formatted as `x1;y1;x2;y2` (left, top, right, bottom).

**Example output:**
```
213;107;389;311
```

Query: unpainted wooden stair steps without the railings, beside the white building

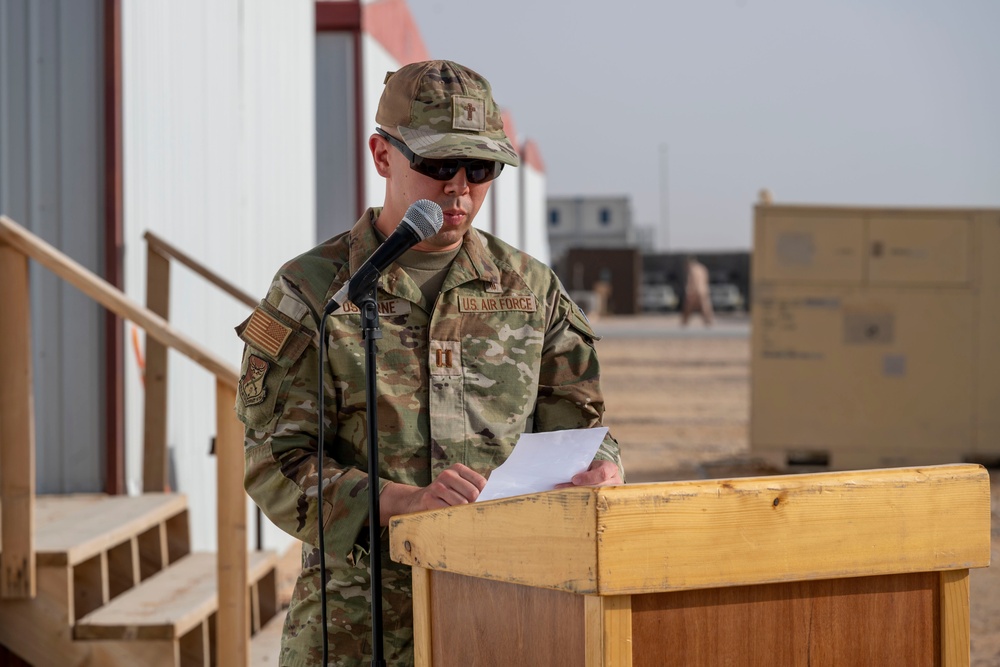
0;493;284;667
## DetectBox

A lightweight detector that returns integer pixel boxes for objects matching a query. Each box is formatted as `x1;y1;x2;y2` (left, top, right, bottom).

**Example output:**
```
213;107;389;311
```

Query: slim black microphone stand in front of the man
353;282;385;667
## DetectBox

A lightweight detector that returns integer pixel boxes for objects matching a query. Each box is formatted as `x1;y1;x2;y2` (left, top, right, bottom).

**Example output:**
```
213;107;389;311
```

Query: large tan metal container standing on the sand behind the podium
750;204;1000;469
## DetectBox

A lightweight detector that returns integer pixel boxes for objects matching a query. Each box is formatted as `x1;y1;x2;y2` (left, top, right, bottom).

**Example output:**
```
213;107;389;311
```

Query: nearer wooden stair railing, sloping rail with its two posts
0;216;250;667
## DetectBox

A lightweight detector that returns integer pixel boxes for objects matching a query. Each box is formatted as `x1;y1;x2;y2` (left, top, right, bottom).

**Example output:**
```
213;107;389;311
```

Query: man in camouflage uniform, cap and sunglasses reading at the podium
236;61;623;667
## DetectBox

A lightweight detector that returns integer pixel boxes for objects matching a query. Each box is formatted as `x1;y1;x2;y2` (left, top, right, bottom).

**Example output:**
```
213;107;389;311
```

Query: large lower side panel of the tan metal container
751;283;976;467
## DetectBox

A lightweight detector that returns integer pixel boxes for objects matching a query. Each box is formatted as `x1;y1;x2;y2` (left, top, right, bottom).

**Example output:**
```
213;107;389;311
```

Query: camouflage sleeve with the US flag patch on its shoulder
236;300;376;565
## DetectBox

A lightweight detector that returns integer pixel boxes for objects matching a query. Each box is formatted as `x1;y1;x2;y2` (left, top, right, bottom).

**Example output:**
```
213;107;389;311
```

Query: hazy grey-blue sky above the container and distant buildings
409;0;1000;250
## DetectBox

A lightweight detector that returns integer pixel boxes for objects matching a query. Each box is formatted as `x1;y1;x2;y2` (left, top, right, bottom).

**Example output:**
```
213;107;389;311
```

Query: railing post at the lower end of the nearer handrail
215;379;250;667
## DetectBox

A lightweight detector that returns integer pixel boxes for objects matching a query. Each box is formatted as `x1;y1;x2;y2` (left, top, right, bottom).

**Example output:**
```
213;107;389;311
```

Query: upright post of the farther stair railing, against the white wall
142;244;170;493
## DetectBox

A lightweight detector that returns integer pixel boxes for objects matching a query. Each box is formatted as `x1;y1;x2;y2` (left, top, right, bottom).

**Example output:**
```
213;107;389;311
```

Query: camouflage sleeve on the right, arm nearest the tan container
534;291;625;480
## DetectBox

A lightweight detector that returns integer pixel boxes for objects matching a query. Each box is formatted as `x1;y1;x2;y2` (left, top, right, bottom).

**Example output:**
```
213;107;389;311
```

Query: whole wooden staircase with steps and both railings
0;215;298;667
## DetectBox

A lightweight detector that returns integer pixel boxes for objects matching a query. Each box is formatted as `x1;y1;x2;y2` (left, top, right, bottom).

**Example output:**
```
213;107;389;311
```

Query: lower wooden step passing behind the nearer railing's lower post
73;551;277;641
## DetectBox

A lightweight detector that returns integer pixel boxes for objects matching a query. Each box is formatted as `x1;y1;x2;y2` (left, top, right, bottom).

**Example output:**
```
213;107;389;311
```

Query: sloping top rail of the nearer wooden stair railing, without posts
0;215;239;388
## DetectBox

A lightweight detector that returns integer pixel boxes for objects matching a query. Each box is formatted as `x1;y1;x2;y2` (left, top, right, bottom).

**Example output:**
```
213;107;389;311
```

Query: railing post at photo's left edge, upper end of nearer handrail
0;242;36;599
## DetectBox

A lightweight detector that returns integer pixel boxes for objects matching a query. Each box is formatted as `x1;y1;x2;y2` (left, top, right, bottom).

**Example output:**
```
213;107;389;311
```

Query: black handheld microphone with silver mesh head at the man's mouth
325;199;444;315
